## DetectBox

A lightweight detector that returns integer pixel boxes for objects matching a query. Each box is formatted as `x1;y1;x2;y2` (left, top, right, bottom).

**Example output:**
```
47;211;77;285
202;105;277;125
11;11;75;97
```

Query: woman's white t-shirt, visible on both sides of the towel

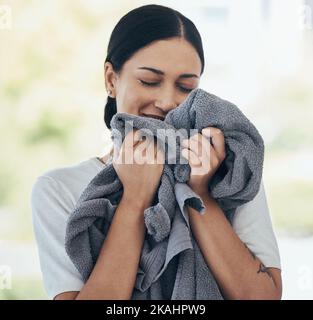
31;157;281;299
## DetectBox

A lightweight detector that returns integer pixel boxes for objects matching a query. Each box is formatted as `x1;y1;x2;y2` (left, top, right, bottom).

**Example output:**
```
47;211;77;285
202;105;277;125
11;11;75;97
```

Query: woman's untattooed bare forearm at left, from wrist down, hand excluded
76;195;145;300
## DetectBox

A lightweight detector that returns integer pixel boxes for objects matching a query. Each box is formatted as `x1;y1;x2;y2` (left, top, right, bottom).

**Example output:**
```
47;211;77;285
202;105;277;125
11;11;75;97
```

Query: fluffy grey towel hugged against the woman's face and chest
65;89;264;300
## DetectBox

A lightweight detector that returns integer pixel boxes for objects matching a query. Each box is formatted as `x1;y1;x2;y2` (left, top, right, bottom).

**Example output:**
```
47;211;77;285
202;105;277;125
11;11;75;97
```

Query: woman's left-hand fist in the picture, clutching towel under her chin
113;129;164;207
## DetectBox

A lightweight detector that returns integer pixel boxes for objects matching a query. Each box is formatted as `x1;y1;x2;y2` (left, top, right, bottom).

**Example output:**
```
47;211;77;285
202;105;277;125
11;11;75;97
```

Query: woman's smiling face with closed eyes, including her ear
105;38;201;118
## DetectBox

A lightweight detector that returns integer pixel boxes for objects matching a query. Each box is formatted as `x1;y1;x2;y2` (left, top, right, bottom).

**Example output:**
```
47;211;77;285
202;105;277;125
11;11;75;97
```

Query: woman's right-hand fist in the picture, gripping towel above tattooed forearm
182;127;226;195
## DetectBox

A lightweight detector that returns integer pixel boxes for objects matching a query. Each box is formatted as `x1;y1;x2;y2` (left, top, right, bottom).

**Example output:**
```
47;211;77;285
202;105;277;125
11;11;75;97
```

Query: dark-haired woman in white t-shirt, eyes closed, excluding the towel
32;5;282;299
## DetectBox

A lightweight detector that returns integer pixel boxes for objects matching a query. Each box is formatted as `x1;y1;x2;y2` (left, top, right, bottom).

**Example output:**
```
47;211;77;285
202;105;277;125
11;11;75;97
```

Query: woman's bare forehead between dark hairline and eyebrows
125;38;201;77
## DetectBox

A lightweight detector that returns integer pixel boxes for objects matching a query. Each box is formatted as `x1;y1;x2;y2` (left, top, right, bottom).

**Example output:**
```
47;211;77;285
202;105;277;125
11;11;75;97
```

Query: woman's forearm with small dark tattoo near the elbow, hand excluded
187;193;277;299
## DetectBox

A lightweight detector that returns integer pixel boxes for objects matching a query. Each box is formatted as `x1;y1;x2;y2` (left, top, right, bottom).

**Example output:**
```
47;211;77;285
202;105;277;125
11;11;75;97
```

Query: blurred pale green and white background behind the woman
0;0;313;299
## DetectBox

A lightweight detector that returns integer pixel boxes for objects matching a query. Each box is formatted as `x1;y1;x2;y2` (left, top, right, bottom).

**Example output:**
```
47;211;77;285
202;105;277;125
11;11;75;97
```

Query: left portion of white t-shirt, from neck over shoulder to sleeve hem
31;158;103;298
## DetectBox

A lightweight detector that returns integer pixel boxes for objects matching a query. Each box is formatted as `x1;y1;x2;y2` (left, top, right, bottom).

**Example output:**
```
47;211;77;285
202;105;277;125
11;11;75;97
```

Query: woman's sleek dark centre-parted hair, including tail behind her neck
104;4;204;129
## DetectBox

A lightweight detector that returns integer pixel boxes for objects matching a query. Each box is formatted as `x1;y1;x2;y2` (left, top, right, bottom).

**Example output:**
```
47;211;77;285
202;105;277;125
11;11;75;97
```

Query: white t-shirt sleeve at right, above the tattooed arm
233;180;281;269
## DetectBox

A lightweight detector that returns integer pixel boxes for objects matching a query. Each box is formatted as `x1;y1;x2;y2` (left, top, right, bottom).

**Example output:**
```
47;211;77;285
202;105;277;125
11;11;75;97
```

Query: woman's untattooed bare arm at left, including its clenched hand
55;129;164;300
